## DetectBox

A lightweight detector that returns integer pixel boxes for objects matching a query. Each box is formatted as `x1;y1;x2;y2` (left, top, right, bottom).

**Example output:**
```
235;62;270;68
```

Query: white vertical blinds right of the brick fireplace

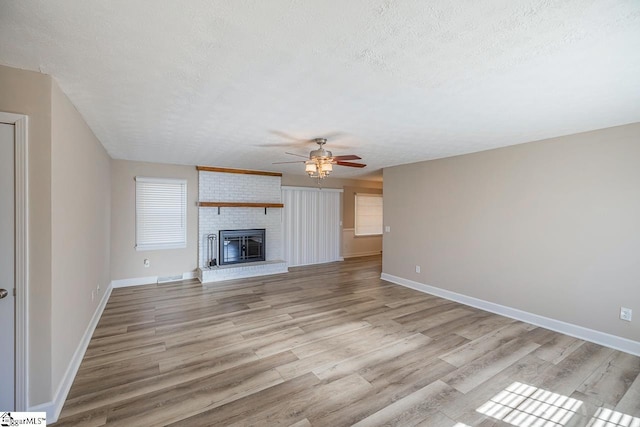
282;187;342;266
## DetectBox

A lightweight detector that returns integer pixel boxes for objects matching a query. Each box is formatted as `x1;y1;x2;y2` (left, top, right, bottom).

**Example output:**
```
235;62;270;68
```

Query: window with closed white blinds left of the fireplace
136;176;187;251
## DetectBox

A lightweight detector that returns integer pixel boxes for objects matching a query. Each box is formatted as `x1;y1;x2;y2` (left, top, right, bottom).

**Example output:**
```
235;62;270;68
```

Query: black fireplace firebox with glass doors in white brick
220;228;266;265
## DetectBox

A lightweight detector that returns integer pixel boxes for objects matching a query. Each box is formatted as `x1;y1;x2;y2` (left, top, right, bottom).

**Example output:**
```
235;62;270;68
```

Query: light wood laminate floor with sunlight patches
55;257;640;427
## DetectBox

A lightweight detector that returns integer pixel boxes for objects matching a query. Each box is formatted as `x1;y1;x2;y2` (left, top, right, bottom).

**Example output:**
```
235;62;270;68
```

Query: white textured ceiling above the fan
0;0;640;178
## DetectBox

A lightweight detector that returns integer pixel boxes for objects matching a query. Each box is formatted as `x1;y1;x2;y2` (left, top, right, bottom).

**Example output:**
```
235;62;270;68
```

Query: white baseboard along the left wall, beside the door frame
29;284;112;424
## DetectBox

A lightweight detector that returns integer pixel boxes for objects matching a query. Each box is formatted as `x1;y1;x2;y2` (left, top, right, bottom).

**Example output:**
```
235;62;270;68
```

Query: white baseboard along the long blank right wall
380;273;640;356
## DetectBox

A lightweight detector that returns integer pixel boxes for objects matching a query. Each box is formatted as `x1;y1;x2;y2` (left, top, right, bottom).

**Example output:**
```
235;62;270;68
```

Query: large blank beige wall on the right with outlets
383;123;640;341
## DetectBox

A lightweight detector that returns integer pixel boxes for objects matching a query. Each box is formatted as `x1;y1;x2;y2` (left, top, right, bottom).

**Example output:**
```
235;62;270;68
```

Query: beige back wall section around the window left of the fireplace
111;160;198;280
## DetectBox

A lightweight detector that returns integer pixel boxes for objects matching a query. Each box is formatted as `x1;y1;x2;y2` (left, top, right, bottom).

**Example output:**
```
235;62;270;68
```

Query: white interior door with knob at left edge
0;123;15;412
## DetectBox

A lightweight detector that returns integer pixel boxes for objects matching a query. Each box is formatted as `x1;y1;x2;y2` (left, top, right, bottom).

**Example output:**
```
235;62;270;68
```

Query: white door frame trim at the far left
0;112;29;411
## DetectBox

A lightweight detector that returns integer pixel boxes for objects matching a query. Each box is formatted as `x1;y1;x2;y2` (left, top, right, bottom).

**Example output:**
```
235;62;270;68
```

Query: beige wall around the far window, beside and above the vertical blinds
282;175;382;257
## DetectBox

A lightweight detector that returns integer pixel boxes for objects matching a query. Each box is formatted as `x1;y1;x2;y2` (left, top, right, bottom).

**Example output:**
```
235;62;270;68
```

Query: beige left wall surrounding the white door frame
0;66;110;406
